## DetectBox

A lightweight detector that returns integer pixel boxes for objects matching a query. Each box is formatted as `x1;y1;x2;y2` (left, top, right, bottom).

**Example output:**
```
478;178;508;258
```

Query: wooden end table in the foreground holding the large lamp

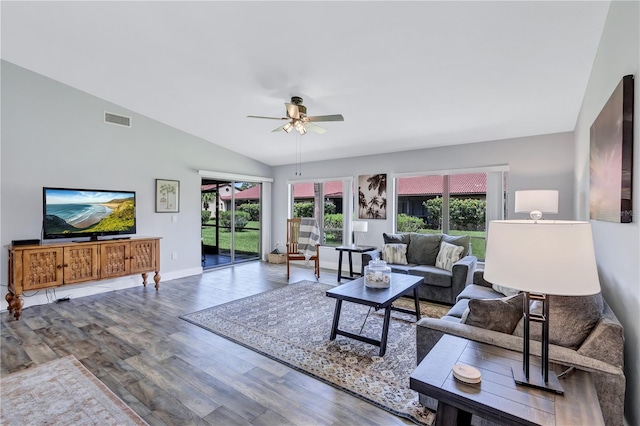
409;334;604;426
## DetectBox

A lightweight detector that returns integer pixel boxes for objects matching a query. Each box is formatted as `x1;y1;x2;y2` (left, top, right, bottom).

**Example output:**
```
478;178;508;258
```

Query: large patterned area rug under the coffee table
181;281;448;425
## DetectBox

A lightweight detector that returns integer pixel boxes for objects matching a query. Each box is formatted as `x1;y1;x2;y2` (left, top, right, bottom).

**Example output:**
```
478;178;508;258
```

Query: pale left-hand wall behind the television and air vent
0;61;271;308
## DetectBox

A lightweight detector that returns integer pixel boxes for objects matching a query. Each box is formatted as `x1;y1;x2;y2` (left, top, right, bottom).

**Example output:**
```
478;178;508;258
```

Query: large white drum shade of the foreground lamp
484;220;600;296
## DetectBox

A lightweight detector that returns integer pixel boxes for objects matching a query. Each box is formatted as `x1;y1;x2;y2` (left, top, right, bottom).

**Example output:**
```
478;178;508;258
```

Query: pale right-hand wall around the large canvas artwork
575;1;640;425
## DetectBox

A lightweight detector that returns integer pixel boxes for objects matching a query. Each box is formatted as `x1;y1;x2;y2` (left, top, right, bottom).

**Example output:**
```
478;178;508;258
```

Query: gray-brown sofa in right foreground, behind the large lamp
416;270;625;426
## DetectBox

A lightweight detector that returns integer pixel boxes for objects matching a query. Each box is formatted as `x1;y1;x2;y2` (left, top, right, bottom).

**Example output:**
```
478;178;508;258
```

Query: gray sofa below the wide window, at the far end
362;232;478;305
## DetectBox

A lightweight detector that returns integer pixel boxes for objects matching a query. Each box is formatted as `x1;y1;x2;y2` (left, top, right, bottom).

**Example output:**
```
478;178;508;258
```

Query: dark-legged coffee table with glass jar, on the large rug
327;273;423;356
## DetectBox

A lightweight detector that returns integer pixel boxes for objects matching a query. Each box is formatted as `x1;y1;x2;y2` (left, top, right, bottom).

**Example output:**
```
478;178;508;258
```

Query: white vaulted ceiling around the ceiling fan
1;1;609;165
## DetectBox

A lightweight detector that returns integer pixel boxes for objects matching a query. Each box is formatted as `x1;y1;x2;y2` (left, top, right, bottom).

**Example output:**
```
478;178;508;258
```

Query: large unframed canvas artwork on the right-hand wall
589;75;634;223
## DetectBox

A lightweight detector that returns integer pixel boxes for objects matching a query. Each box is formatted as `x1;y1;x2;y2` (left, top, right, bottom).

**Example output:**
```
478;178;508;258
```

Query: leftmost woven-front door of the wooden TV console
21;247;64;291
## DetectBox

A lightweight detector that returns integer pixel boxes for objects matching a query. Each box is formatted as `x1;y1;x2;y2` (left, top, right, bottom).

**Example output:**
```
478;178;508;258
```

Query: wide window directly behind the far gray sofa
396;171;506;260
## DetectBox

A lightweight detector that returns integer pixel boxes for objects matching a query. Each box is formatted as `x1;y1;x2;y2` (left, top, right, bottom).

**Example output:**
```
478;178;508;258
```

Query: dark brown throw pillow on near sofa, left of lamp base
460;294;524;334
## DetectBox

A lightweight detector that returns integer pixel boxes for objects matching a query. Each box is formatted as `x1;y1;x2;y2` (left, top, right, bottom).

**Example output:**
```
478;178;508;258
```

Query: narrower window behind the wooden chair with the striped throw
291;180;348;247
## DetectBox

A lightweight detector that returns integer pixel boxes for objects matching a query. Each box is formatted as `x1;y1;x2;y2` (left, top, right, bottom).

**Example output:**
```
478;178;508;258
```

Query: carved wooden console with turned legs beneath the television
5;237;160;320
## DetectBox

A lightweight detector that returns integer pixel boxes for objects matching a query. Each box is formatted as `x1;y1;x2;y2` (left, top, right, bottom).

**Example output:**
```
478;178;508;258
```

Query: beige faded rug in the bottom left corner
0;355;147;426
